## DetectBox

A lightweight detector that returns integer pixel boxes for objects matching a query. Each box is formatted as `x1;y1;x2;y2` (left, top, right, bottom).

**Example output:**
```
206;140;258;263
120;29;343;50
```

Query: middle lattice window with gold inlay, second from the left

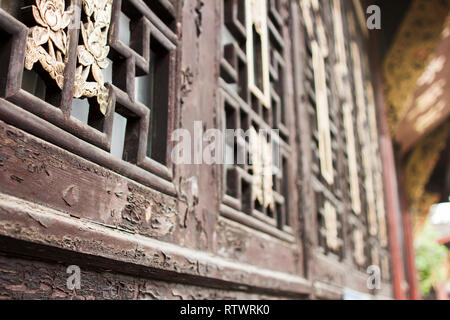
220;0;293;240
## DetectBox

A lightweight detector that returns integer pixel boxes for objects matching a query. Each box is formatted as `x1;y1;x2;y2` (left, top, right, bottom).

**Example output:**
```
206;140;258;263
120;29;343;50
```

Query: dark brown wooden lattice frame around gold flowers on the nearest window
0;0;180;195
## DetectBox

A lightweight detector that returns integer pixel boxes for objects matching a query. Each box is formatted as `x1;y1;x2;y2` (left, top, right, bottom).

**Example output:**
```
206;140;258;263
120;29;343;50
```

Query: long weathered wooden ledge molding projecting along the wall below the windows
0;193;311;297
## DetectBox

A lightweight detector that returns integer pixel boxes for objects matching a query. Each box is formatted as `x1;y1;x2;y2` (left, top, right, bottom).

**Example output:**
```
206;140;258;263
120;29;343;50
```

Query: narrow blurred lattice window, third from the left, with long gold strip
300;0;346;258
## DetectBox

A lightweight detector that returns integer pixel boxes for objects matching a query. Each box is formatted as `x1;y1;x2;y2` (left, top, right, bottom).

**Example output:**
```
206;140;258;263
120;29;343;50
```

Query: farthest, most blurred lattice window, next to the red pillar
342;0;390;280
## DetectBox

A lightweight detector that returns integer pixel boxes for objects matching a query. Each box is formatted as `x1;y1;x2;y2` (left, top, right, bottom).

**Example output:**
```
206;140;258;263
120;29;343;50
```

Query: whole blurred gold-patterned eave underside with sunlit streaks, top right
384;0;450;153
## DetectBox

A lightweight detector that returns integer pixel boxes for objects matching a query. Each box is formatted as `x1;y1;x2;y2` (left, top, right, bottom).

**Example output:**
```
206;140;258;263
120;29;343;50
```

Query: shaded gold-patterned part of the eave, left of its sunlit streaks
384;0;450;133
